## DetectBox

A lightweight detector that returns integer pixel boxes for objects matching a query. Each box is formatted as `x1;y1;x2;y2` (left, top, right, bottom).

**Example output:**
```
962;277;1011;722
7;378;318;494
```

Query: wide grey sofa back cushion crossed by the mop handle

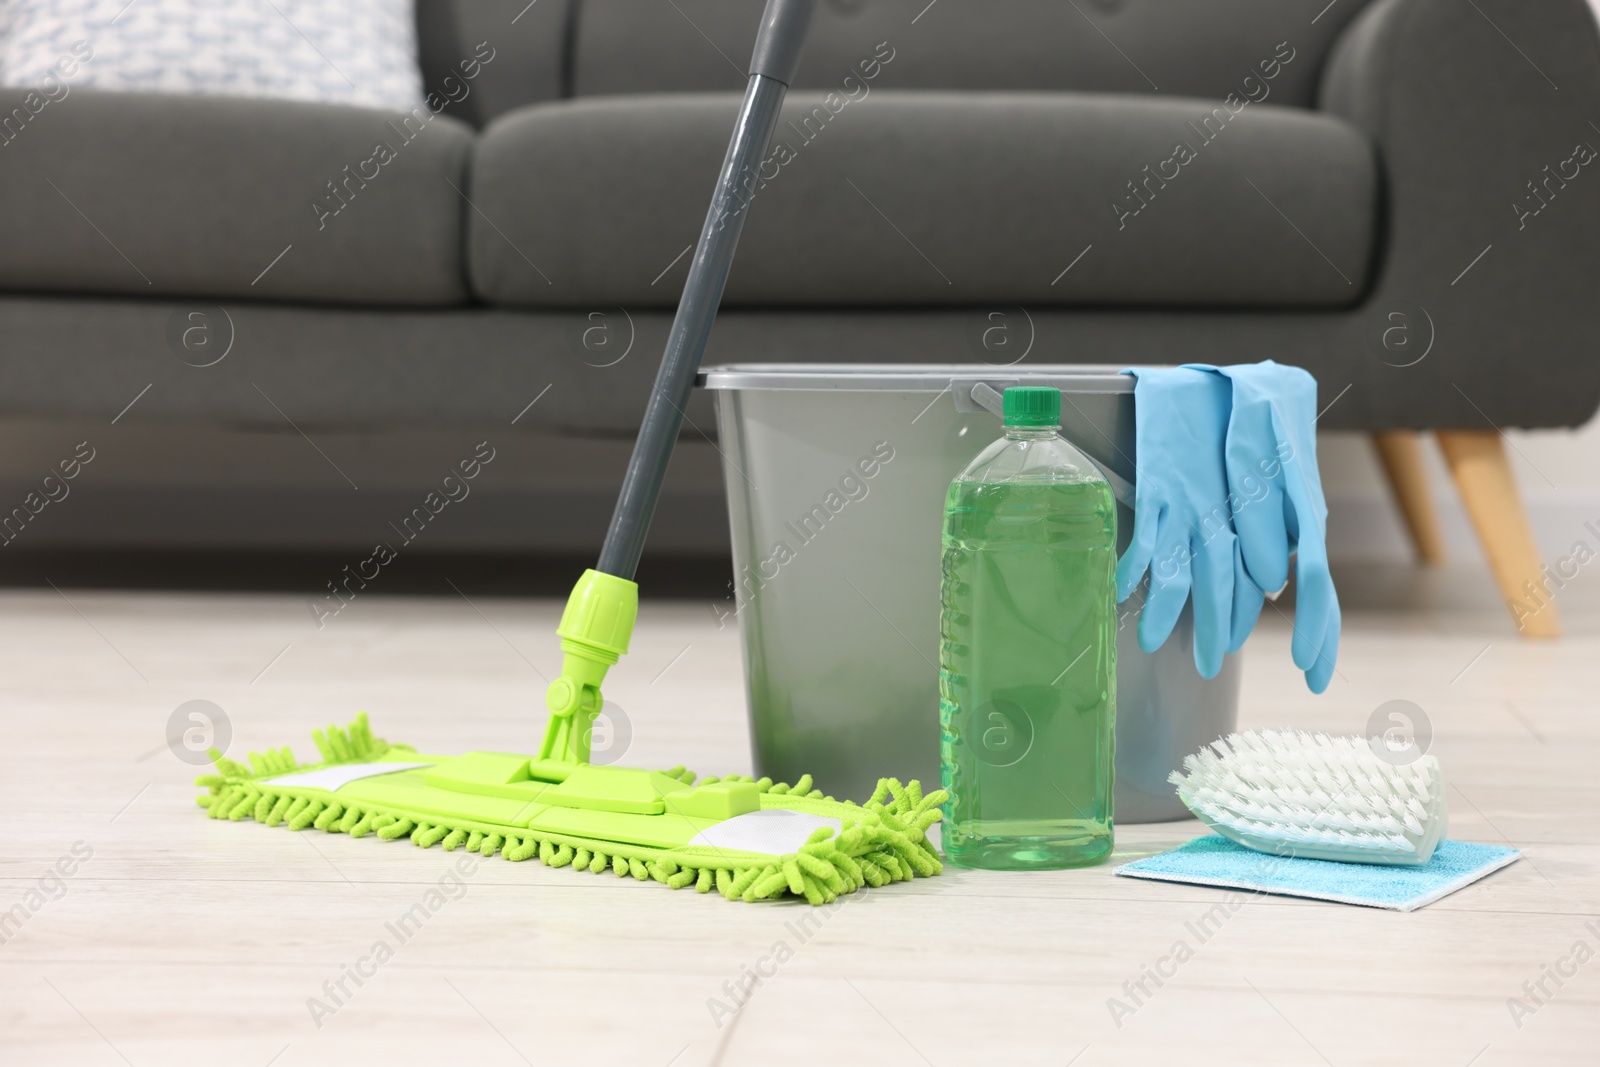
569;0;1366;107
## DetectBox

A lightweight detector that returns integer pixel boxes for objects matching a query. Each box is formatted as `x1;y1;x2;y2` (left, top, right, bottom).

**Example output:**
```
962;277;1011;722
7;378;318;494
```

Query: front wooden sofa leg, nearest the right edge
1438;430;1562;637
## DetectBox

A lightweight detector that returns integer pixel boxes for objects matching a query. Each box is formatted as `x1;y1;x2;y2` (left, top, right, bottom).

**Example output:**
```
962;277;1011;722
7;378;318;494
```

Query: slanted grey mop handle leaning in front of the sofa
595;0;816;581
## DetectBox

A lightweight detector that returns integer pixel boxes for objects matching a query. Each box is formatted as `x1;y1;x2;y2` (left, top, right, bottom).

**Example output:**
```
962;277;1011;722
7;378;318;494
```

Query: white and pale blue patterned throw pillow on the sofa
0;0;422;110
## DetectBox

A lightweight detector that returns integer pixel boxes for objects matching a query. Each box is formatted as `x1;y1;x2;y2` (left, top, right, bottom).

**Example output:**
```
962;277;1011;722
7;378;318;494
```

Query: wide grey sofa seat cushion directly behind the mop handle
467;90;1378;307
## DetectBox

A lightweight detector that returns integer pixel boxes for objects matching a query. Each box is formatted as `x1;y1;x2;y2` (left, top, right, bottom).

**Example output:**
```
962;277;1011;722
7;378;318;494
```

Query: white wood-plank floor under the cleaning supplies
0;569;1600;1067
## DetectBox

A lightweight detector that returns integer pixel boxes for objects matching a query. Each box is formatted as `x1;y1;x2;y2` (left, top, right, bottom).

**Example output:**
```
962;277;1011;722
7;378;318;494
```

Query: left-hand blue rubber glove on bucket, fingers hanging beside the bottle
1117;368;1262;678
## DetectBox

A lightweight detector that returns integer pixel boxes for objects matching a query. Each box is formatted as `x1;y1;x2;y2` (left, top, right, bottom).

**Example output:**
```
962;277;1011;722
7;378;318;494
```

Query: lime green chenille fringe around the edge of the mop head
195;712;946;905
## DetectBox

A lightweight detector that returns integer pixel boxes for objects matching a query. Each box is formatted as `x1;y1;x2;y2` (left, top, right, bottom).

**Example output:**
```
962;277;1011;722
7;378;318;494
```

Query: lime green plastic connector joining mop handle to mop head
534;569;638;777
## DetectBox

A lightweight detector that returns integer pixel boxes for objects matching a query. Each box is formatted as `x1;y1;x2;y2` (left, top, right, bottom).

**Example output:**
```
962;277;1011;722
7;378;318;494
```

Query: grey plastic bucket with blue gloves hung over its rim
699;363;1240;822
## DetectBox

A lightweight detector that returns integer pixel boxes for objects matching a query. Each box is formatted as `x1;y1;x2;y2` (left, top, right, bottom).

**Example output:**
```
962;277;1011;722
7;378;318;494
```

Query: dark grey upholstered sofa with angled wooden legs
0;0;1600;633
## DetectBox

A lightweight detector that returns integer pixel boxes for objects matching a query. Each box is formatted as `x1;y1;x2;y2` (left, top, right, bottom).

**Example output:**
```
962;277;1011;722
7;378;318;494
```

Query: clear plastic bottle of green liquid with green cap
939;387;1117;870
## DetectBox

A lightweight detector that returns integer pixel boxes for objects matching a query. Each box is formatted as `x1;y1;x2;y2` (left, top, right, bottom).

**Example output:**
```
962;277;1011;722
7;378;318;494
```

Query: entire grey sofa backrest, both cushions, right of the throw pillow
418;0;1370;126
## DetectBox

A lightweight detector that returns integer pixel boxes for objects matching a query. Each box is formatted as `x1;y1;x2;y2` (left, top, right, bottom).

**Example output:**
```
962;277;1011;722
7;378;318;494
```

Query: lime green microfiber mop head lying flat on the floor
195;713;944;904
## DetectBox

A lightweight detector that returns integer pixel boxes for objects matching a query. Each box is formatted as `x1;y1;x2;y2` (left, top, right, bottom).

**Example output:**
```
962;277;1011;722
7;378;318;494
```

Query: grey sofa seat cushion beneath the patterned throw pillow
0;90;472;306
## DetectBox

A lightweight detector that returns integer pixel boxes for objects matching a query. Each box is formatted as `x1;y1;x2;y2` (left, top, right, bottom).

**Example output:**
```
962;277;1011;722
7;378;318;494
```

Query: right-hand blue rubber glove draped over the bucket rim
1203;360;1341;693
